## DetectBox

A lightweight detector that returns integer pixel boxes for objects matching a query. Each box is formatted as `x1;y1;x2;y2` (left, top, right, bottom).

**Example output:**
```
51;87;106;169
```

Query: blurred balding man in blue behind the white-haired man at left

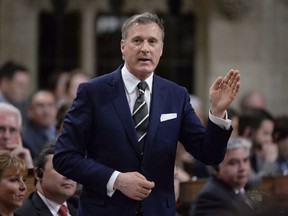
22;90;57;158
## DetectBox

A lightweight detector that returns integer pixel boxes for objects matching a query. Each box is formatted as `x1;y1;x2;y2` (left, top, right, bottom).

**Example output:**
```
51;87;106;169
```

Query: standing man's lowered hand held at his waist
114;172;155;201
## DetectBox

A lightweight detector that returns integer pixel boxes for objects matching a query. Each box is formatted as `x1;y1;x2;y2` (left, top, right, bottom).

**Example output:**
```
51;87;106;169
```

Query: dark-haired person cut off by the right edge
273;116;288;175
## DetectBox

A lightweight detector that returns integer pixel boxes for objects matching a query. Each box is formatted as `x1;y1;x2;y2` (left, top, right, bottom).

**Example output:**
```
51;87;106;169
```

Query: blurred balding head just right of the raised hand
240;90;266;112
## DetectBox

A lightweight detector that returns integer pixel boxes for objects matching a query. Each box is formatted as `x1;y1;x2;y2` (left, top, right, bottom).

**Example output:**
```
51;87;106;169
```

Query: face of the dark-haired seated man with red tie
40;154;76;202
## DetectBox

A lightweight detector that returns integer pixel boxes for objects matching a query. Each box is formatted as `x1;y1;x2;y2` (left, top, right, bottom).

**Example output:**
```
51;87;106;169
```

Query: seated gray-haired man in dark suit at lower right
190;137;254;216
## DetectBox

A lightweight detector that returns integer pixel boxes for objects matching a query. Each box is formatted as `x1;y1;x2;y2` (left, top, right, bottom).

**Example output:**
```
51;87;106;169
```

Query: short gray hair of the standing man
121;12;165;41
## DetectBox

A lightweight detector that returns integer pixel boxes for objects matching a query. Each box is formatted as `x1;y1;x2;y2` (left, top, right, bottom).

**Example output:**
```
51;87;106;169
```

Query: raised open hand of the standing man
209;69;240;118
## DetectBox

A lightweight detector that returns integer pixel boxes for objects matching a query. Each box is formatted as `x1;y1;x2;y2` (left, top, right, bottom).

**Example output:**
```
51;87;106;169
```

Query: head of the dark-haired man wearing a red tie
34;142;76;204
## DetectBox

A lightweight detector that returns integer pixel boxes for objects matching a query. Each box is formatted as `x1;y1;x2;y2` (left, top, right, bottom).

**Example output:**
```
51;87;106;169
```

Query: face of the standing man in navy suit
121;23;163;79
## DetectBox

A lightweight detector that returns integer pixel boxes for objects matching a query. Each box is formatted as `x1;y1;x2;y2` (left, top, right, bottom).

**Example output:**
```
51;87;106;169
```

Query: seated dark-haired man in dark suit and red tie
16;142;77;216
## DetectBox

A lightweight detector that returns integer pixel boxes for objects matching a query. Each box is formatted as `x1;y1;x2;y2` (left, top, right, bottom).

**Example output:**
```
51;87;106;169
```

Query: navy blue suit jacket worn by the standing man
53;66;232;216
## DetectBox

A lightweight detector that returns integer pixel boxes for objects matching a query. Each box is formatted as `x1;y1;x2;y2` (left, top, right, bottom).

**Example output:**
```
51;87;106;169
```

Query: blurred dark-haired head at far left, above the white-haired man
0;61;30;106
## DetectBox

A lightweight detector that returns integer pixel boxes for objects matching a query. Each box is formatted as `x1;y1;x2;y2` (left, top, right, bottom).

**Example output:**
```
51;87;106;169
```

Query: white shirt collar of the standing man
121;65;154;94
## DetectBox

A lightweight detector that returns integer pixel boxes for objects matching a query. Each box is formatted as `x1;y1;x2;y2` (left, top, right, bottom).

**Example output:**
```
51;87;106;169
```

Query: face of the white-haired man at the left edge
0;112;20;152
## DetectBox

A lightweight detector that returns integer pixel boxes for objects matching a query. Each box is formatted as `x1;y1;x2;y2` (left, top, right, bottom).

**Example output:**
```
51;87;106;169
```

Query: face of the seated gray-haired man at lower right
217;148;250;189
